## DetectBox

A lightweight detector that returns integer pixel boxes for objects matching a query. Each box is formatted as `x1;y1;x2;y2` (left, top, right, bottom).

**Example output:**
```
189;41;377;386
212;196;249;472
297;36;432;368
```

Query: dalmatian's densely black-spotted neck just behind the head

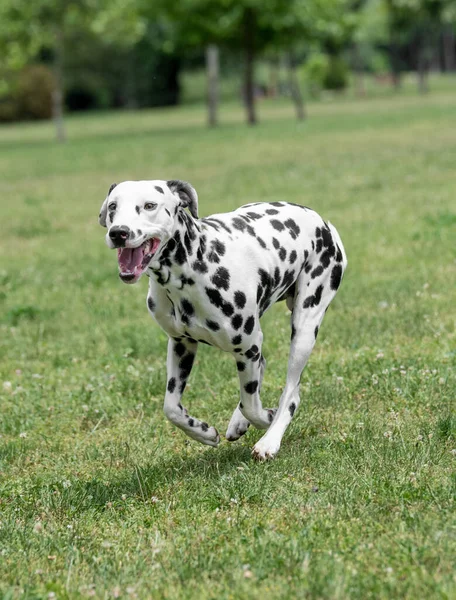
147;207;201;285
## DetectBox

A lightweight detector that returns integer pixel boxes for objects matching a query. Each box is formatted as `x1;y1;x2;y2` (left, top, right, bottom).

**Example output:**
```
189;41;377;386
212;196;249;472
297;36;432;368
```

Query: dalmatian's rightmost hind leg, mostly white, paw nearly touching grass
252;248;345;460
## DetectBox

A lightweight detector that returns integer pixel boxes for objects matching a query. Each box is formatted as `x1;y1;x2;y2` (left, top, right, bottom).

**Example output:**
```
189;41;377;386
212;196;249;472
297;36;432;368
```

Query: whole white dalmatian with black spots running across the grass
99;180;347;460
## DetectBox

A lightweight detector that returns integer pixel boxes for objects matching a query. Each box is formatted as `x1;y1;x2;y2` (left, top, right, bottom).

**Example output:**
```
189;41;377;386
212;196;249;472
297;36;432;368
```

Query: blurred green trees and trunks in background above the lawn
0;0;456;140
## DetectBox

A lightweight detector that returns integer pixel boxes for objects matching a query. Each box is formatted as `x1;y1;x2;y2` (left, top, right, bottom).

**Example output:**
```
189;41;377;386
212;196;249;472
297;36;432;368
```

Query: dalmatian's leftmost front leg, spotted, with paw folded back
163;338;220;446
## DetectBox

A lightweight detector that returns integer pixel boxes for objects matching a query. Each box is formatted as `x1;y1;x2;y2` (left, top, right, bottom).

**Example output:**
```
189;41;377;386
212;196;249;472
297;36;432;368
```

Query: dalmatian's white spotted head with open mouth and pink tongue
98;180;198;283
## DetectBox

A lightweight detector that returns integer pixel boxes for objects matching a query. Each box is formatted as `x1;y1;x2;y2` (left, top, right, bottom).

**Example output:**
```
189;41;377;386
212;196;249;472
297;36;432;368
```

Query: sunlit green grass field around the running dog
0;89;456;600
